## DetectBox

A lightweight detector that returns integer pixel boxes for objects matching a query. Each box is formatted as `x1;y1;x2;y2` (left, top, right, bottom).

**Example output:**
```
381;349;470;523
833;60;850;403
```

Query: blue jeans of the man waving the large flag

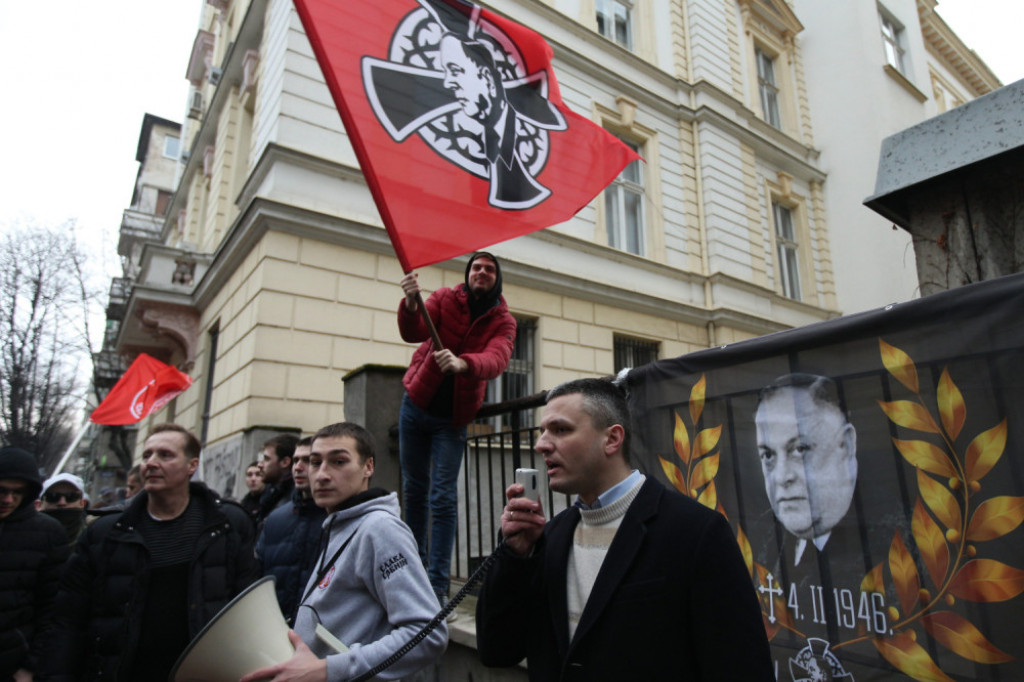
398;394;466;595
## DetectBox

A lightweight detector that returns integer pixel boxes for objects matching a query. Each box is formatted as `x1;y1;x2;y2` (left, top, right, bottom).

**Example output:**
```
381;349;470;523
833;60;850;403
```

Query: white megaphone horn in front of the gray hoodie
169;576;295;682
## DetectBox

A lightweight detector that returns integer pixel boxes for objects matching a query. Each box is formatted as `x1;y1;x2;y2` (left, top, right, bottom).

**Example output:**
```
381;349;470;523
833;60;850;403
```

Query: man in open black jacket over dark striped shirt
44;424;257;682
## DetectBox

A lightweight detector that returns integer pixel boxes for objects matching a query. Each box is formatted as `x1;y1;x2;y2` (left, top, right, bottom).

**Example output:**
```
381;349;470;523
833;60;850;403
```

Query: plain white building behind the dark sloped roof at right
794;0;1000;314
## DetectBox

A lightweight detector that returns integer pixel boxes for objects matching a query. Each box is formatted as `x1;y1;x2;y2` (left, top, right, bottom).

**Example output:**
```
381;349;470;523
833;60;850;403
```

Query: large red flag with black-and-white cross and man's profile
295;0;638;271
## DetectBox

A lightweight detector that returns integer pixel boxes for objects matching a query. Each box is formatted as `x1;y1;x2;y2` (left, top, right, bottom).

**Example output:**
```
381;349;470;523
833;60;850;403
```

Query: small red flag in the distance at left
89;353;191;426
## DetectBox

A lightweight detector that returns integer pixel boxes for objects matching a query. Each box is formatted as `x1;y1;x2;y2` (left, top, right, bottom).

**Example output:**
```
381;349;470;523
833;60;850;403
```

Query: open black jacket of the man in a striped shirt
41;483;258;681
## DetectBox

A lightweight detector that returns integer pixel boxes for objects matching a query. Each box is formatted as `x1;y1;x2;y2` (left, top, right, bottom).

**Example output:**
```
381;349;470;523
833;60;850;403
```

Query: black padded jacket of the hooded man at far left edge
0;495;71;680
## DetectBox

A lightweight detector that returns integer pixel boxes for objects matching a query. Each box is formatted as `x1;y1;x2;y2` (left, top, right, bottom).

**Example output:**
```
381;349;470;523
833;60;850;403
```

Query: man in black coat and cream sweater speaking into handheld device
476;379;775;681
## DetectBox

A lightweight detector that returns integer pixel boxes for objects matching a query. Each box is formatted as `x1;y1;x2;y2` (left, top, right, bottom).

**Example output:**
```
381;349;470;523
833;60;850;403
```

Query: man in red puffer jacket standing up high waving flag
398;251;516;604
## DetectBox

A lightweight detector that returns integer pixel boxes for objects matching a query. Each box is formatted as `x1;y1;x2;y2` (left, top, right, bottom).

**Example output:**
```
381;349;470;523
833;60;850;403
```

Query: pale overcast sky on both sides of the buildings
0;0;1024;275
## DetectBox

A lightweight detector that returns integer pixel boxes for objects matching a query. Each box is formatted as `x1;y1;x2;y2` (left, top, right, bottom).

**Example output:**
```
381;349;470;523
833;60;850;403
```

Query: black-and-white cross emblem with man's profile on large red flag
362;0;566;210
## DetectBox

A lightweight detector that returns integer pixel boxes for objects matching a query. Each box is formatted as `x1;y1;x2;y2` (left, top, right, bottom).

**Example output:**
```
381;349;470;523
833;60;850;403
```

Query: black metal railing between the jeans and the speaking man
452;392;570;582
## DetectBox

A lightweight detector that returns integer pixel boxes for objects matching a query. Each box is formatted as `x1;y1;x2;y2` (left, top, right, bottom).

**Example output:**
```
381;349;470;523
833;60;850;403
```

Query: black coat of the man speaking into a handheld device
476;478;775;682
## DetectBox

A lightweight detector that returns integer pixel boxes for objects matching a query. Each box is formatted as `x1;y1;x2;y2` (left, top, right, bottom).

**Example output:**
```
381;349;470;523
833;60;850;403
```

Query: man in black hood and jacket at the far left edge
0;447;69;682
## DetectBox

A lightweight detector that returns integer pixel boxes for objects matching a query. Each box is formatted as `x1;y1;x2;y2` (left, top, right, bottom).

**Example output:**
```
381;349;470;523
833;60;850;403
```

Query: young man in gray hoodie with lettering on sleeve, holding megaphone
241;422;447;682
